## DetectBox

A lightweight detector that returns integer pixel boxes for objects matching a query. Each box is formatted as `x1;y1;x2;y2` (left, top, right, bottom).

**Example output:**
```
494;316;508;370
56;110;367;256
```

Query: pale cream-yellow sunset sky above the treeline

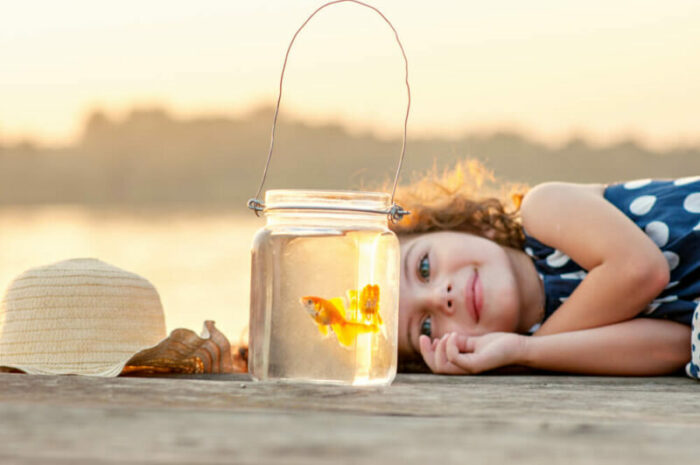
0;0;700;146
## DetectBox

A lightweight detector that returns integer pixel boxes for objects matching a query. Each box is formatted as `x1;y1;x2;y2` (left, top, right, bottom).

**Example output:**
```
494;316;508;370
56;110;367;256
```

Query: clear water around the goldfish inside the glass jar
249;228;399;385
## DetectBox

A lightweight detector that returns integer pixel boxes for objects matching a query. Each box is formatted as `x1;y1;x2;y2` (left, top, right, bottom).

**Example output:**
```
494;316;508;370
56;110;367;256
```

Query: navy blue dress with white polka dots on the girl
524;176;700;378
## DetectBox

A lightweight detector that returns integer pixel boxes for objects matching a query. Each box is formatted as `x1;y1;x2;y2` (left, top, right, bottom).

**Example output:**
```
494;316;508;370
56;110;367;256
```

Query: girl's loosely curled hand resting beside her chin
419;333;527;375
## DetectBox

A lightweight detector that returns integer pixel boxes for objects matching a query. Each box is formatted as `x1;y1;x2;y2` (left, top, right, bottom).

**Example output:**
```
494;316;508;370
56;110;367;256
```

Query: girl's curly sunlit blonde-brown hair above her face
392;159;527;248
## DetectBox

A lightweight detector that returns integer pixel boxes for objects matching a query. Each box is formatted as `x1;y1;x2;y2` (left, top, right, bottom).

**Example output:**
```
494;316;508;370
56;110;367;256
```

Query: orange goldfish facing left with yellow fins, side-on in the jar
300;296;379;347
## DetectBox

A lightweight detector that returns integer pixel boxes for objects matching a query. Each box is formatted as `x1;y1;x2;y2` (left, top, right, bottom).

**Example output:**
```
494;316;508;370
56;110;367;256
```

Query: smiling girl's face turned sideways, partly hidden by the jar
399;231;520;356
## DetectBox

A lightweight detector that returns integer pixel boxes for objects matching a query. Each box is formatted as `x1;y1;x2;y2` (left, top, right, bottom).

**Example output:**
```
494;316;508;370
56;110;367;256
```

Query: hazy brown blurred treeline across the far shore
0;108;700;209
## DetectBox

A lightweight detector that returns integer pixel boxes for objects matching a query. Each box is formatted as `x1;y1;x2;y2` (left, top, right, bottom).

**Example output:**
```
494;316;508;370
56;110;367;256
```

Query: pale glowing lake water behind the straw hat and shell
0;206;264;342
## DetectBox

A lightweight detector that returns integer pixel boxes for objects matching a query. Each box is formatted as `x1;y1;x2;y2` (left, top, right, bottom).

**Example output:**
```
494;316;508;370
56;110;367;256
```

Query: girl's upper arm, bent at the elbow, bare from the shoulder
521;183;669;335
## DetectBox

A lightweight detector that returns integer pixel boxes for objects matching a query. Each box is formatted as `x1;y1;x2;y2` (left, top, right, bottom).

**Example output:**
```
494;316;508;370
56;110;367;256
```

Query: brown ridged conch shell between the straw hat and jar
121;320;239;375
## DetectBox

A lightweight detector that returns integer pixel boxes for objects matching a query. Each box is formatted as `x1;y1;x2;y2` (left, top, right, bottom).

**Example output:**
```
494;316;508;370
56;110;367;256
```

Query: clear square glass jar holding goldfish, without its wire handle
248;190;400;385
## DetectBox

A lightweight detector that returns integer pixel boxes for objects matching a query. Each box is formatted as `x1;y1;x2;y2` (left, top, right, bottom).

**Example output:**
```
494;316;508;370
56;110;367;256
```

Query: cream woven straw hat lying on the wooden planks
0;259;166;376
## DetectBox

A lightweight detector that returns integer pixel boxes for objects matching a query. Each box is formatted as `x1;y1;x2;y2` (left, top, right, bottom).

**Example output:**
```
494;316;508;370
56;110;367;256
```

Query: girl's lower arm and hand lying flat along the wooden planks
420;318;691;376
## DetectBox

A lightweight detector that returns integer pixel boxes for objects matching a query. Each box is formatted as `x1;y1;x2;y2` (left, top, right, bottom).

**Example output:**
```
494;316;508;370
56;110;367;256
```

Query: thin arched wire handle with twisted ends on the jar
248;0;411;222
